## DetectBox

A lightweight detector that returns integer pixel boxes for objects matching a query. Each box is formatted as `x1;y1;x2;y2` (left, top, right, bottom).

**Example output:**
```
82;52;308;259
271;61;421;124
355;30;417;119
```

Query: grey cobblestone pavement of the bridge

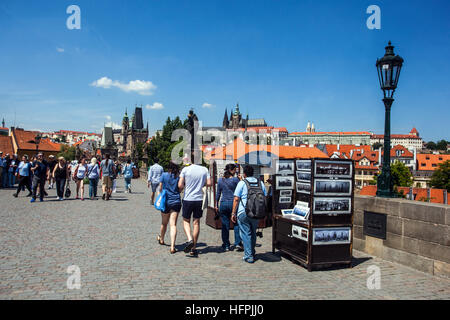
0;180;450;300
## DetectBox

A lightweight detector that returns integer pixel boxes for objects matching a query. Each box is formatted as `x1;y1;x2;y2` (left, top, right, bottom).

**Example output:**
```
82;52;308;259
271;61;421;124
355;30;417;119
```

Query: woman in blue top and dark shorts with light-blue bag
157;162;181;254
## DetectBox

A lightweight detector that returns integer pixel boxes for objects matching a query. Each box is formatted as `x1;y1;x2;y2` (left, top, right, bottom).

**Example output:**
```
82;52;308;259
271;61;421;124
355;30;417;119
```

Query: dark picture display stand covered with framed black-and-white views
272;158;355;271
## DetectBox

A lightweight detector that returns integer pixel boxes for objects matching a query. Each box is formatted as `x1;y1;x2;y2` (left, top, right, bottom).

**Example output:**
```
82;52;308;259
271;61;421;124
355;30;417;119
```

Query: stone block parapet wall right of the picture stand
353;196;450;277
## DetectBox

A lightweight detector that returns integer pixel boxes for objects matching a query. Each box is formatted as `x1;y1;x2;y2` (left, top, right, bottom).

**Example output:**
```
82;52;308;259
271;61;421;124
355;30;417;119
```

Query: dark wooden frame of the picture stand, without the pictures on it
272;158;355;271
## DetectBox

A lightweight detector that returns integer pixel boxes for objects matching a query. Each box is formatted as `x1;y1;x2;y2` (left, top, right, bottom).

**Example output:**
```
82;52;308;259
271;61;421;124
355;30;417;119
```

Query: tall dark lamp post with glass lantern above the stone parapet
376;41;403;198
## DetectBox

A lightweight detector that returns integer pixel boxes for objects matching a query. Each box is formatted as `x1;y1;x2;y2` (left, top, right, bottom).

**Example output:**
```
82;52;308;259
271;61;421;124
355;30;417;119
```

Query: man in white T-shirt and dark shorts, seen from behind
178;164;211;256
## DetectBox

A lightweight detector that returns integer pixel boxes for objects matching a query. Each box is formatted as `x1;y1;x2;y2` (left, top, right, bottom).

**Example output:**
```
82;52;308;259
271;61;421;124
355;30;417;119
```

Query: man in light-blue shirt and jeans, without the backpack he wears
231;165;267;263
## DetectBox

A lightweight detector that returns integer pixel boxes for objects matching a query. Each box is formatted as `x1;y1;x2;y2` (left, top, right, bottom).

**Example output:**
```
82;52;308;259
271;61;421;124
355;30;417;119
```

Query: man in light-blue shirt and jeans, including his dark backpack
231;166;267;263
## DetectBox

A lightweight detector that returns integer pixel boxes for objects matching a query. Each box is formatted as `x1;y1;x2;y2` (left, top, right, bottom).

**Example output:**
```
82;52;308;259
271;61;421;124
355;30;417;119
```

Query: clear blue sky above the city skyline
0;0;450;141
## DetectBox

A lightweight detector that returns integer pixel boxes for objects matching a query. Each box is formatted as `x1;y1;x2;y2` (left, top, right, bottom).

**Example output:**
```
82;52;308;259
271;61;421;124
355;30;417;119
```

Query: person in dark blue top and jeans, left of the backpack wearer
215;163;243;251
